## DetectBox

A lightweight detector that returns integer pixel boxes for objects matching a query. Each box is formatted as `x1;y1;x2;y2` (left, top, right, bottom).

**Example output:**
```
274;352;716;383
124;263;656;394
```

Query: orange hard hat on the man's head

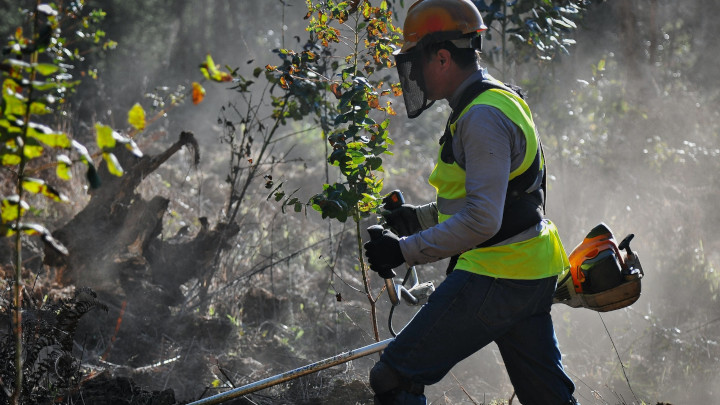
400;0;487;53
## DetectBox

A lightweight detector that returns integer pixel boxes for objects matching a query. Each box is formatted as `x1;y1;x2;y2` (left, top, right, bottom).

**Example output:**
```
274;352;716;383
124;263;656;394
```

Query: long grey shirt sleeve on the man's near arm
400;105;525;265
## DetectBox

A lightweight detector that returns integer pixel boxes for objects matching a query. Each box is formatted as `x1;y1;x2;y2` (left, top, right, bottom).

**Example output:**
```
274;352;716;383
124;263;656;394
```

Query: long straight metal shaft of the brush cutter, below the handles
183;338;395;405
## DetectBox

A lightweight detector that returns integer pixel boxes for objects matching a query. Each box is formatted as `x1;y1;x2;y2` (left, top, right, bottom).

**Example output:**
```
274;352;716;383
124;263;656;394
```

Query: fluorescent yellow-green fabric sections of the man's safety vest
429;89;569;279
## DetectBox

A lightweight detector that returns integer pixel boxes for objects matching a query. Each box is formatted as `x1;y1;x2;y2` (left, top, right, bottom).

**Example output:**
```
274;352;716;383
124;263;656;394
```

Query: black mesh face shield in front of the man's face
394;47;435;118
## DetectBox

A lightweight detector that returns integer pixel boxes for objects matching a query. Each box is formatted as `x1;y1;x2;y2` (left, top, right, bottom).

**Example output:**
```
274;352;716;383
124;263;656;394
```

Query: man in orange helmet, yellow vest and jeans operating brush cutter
364;0;577;405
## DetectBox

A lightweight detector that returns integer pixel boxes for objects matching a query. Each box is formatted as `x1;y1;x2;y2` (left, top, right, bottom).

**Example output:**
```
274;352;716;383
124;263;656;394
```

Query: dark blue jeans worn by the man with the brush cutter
380;270;575;405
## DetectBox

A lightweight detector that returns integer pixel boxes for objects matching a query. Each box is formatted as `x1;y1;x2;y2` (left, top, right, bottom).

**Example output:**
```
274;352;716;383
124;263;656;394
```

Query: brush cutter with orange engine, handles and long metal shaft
188;194;644;405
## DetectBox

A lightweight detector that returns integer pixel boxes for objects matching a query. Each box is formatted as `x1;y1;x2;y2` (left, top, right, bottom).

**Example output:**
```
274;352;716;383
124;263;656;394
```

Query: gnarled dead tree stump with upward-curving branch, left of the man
45;132;239;305
